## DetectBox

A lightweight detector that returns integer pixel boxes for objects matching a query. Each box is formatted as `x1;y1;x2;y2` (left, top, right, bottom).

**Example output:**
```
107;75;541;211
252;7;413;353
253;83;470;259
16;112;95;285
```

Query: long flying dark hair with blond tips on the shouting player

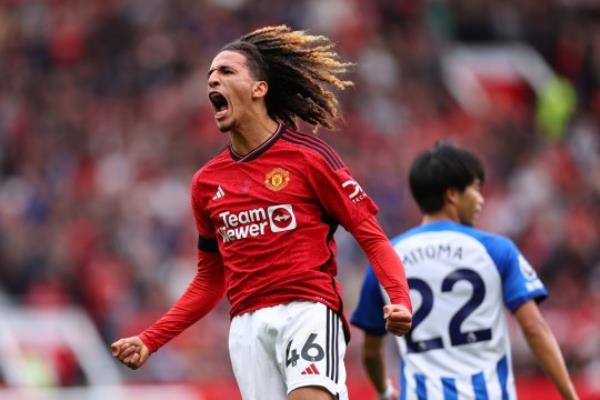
221;25;353;132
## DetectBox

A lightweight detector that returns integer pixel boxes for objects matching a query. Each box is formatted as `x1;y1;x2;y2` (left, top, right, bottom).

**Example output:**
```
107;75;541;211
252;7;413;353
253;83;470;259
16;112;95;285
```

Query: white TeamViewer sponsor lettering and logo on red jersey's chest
219;204;297;243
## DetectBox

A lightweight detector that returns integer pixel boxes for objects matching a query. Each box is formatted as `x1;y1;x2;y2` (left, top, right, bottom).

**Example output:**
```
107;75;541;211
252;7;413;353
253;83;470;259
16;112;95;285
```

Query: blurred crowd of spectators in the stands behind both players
0;0;600;390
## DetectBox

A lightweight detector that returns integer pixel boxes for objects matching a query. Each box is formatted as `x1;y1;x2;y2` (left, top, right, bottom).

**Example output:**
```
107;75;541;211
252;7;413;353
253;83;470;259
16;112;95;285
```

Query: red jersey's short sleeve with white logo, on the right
307;150;378;231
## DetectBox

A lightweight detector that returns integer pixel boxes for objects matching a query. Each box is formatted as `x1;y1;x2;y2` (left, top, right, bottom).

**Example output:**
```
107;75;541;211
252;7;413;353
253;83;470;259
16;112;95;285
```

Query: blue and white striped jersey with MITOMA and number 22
351;221;547;400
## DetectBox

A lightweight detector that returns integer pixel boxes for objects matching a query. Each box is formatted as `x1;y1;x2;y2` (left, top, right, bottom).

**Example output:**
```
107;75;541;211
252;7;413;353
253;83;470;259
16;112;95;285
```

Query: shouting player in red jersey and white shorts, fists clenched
112;26;411;400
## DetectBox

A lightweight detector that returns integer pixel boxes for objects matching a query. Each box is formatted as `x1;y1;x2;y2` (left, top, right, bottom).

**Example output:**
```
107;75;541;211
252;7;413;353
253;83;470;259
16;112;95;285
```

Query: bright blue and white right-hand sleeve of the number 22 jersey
487;238;548;313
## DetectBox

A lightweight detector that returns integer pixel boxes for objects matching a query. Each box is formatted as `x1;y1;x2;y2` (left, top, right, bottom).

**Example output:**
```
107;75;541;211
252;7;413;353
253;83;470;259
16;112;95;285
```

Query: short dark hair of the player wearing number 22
409;143;485;214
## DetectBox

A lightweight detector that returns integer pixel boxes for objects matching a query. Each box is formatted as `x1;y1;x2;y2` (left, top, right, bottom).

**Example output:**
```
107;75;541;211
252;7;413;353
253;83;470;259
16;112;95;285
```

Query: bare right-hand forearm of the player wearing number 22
514;300;579;400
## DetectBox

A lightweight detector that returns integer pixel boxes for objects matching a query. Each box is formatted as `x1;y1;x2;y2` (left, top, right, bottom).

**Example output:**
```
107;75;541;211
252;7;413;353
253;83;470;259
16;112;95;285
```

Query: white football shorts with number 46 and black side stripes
229;301;348;400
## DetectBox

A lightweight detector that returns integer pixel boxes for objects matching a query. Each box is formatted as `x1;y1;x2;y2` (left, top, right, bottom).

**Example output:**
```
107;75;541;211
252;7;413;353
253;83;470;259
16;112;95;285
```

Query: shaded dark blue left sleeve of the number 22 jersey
350;267;387;336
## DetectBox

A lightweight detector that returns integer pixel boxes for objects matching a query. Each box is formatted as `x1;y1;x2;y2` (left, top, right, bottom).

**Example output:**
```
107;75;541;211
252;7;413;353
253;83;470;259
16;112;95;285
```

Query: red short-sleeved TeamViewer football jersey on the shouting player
192;125;377;316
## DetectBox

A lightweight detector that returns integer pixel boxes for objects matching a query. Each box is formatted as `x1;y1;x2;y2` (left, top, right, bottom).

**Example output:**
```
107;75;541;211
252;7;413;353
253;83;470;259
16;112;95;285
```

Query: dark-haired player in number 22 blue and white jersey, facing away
351;144;577;400
